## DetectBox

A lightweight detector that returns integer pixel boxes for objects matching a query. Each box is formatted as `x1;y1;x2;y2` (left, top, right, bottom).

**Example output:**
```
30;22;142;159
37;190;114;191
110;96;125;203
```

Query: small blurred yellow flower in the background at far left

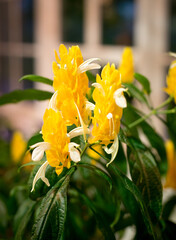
10;131;27;163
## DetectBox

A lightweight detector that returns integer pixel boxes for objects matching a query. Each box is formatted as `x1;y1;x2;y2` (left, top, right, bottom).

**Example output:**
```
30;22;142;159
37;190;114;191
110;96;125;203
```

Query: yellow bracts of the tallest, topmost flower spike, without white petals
53;44;90;126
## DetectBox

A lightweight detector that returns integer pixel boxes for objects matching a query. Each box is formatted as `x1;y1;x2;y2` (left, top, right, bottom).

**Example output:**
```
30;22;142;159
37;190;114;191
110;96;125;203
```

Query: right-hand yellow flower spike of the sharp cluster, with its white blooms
90;63;127;166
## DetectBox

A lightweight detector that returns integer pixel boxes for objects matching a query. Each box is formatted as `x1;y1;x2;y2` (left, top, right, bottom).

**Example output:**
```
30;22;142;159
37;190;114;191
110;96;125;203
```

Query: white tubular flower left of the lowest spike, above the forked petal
30;142;50;161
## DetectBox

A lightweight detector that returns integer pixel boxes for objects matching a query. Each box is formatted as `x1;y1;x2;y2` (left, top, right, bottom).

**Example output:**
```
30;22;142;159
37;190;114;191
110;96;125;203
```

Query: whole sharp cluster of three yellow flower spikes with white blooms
31;44;126;191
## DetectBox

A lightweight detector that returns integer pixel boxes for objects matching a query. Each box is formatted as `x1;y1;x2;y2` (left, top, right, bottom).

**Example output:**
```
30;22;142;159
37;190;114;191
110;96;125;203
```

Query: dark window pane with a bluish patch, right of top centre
103;0;135;46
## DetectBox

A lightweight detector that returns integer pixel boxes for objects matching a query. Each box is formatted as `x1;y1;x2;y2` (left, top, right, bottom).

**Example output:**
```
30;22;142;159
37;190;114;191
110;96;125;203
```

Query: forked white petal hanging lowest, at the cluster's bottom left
31;161;50;192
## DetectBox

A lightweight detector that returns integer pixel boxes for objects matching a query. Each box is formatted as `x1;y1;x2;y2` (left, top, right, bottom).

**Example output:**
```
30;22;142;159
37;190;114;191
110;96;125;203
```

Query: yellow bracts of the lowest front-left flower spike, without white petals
42;109;70;175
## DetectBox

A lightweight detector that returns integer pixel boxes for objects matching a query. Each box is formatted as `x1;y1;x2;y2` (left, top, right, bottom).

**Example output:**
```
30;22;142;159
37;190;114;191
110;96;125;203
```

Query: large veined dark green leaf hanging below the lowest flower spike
31;168;75;240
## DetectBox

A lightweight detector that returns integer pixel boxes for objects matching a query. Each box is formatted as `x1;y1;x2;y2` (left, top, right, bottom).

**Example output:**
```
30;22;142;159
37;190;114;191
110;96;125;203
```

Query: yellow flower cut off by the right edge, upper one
164;60;176;103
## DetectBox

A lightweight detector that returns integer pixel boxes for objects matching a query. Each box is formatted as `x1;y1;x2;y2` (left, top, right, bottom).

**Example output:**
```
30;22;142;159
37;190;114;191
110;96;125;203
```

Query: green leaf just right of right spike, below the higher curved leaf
123;83;150;107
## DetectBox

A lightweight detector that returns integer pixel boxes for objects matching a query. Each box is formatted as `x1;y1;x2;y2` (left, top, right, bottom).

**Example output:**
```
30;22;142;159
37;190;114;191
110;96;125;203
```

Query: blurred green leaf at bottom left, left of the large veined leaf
15;200;36;240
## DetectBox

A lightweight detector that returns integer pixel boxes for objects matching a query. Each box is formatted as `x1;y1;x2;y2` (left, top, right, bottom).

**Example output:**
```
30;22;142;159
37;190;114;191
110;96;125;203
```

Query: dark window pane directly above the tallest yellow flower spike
63;0;83;42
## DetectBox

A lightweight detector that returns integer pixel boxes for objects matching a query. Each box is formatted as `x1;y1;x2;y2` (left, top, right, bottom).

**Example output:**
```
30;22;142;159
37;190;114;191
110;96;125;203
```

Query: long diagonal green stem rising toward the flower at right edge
128;97;173;128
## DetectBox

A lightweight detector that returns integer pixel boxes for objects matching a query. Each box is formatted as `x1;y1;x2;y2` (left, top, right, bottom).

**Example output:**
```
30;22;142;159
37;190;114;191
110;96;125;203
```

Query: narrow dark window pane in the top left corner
0;1;8;41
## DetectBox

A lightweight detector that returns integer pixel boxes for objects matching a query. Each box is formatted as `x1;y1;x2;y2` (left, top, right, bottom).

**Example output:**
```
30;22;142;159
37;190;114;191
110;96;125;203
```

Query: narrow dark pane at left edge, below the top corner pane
0;56;9;94
